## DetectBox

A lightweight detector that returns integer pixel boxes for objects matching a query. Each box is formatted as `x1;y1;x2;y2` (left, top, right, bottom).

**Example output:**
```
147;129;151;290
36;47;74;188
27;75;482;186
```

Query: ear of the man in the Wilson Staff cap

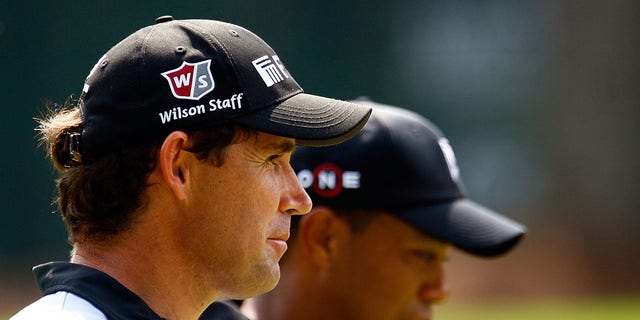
157;131;189;200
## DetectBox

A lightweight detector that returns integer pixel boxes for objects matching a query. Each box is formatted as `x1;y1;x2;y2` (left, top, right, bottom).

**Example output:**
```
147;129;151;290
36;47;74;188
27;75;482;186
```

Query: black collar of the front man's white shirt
33;262;162;320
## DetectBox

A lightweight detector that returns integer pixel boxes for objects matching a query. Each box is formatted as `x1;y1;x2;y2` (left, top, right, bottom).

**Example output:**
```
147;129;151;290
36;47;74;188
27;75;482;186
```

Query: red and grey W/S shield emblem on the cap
162;60;215;100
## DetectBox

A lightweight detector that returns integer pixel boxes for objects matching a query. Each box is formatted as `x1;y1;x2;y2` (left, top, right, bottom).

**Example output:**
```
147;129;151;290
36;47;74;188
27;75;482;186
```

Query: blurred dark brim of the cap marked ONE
394;199;527;257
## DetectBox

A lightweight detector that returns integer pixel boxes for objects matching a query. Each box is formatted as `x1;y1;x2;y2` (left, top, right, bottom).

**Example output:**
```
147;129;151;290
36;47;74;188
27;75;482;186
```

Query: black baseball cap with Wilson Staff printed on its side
76;16;371;158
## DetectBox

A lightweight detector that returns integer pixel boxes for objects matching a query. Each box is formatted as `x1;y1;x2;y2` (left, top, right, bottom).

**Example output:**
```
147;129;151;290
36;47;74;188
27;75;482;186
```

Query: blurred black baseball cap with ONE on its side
291;101;526;257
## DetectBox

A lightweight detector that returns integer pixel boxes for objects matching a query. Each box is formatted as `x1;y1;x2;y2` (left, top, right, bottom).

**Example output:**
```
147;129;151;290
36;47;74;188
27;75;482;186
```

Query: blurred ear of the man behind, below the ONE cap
297;206;349;270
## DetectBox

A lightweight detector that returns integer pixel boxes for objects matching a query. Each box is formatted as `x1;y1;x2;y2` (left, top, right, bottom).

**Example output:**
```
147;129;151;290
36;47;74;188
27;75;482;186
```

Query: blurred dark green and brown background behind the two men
0;0;640;317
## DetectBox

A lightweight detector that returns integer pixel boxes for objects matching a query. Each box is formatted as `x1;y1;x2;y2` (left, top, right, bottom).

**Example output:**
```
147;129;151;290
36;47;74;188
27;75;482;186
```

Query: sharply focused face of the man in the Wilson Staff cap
178;133;311;299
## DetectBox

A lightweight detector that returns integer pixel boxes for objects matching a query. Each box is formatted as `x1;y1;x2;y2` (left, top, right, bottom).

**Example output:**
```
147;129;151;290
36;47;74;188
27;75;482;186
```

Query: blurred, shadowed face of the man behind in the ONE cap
330;213;449;320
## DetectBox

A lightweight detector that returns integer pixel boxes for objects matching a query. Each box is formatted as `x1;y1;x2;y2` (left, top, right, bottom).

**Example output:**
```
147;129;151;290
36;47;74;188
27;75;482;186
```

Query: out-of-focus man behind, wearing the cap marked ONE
242;100;526;320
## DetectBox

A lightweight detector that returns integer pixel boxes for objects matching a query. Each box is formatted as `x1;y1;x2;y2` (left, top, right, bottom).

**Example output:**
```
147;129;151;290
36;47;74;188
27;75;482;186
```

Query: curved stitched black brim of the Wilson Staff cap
234;93;371;146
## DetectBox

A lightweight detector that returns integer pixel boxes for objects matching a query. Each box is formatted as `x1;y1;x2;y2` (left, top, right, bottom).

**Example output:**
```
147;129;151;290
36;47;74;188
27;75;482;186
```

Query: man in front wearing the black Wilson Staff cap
12;17;371;320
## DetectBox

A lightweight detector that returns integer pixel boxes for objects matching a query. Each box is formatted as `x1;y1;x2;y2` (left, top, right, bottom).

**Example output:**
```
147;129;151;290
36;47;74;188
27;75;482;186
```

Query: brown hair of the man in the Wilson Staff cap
36;100;255;243
